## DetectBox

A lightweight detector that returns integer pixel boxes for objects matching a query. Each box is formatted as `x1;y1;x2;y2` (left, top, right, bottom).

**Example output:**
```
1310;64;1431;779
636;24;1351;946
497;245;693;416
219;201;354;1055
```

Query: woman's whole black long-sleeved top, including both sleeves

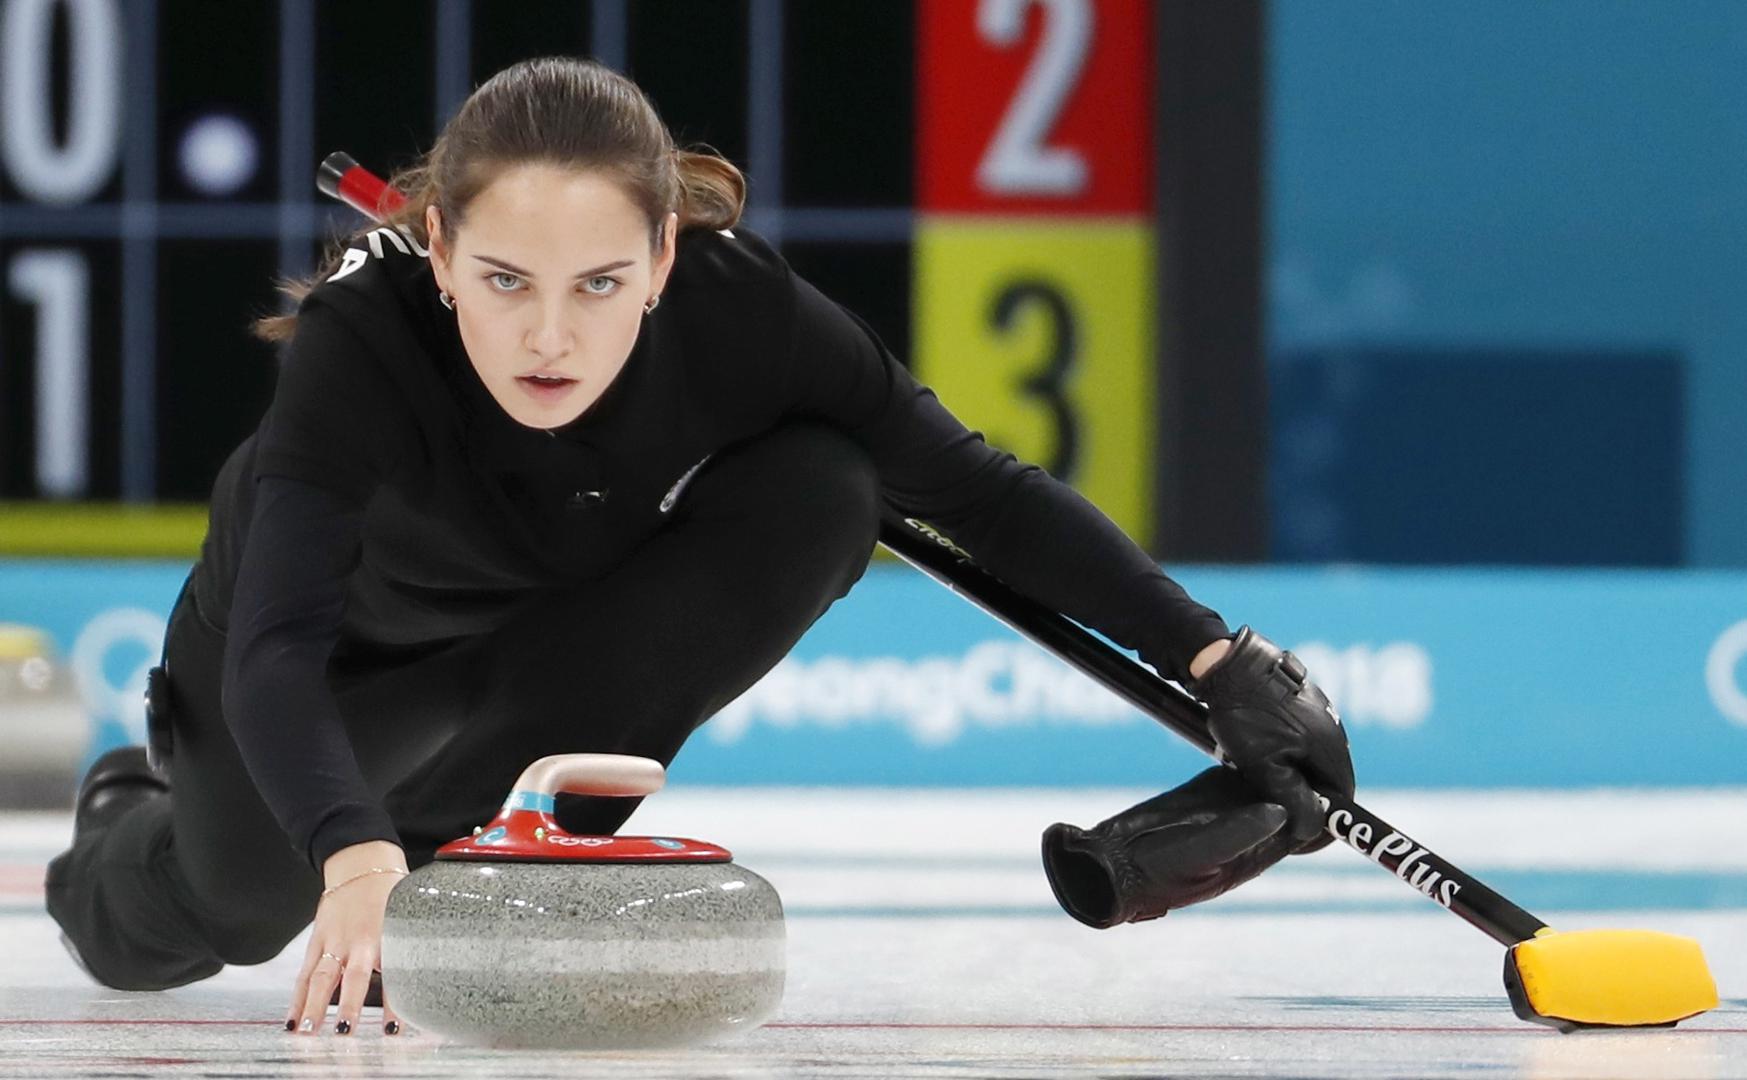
197;227;1228;869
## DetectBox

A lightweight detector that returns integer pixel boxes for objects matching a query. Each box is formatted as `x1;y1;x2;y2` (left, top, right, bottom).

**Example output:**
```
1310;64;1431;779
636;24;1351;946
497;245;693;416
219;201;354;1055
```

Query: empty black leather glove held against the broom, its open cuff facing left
1043;765;1293;930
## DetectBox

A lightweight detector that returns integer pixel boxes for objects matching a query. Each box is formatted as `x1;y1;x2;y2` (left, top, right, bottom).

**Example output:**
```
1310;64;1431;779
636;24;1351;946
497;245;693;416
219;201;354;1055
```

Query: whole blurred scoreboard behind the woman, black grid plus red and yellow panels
0;0;1257;543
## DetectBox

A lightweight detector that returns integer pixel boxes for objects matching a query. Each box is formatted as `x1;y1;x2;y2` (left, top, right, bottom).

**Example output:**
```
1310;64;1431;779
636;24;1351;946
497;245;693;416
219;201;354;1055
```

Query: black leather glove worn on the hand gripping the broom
1190;626;1354;853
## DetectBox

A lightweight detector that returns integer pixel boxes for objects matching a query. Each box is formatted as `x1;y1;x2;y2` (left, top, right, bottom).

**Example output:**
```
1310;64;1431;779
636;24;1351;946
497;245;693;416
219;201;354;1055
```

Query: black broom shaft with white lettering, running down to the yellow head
879;517;1546;945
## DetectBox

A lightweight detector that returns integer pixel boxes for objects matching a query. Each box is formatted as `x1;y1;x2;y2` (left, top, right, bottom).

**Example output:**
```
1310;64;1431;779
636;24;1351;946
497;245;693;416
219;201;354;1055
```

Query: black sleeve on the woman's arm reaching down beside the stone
222;298;411;870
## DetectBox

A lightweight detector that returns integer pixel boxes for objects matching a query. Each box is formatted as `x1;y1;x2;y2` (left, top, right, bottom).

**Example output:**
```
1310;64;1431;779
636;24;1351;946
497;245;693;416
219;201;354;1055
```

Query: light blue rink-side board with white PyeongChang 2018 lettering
0;559;1747;788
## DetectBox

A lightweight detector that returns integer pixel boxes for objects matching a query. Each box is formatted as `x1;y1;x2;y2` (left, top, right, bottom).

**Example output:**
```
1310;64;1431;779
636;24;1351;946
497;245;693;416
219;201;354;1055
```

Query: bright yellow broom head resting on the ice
1504;928;1717;1031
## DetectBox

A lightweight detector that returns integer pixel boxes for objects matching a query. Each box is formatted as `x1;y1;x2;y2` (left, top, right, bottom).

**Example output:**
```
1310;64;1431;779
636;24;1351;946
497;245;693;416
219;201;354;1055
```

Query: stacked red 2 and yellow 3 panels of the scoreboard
914;0;1157;543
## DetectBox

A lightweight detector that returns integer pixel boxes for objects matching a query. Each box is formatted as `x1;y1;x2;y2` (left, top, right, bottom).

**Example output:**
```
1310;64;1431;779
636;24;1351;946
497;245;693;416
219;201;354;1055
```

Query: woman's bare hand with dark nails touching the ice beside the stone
285;863;400;1035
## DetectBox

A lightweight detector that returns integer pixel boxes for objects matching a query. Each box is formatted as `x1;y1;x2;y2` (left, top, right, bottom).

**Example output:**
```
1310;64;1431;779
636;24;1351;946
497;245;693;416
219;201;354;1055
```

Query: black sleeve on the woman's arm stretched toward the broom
786;267;1230;682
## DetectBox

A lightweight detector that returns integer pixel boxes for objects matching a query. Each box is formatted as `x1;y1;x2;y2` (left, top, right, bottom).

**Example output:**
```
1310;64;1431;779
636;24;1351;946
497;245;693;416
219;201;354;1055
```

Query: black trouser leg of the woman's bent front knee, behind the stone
379;423;879;865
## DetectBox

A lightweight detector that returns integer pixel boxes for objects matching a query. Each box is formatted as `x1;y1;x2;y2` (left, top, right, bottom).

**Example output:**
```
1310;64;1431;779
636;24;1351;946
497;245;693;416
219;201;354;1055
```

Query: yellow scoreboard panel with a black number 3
912;215;1157;547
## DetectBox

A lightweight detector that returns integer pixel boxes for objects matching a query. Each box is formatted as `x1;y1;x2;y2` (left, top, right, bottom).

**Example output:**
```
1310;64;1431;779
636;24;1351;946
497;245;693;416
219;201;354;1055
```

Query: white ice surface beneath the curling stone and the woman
0;786;1747;1078
